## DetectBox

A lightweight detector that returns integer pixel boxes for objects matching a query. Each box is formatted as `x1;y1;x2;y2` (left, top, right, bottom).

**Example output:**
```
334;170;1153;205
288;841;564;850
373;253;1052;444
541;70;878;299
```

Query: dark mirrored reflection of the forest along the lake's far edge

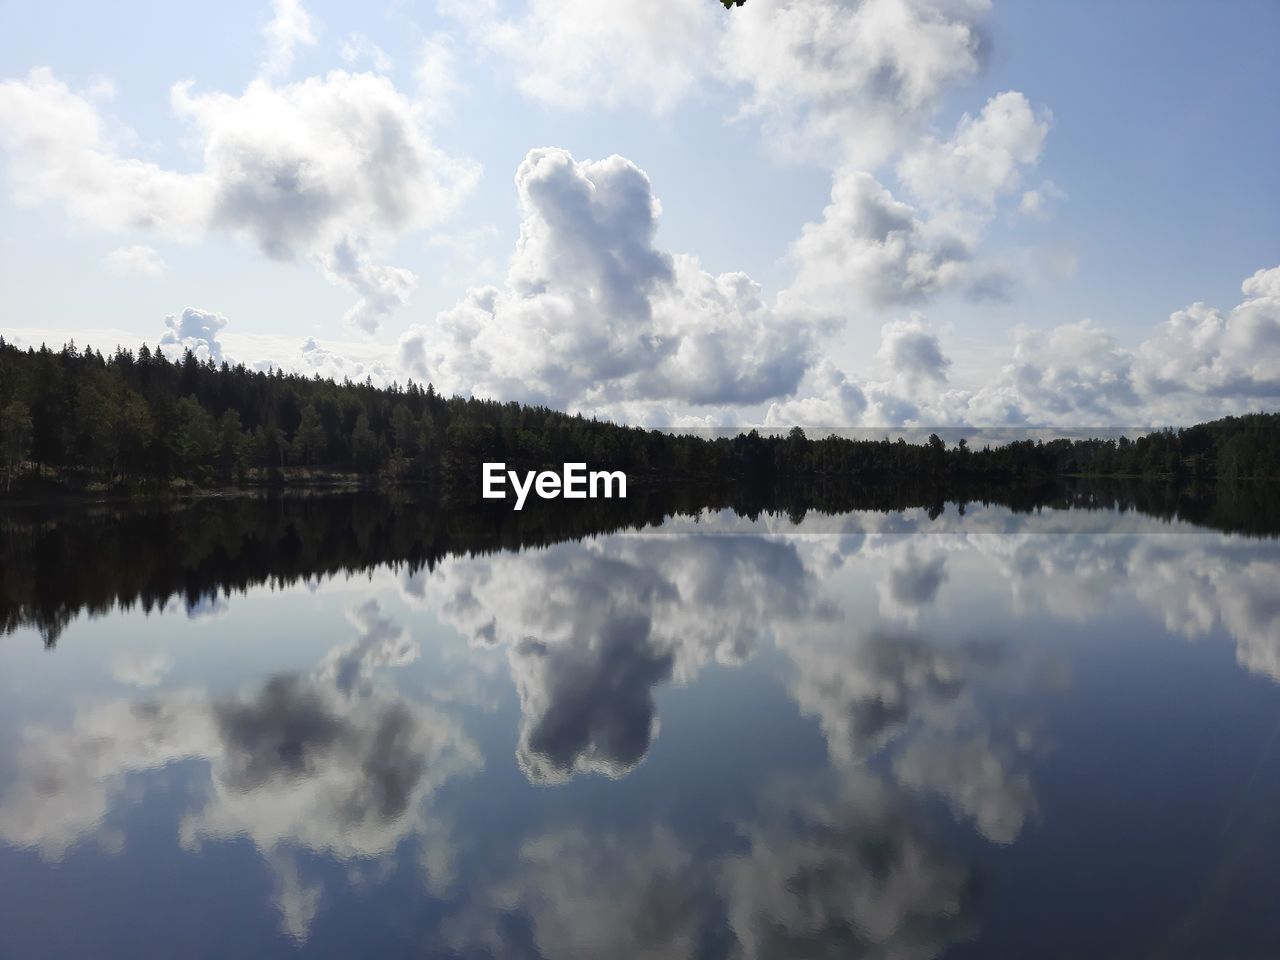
0;481;1280;645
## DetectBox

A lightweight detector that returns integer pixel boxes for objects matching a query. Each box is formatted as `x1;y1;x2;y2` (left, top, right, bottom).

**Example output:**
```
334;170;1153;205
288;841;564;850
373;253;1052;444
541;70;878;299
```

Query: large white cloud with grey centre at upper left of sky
0;24;477;332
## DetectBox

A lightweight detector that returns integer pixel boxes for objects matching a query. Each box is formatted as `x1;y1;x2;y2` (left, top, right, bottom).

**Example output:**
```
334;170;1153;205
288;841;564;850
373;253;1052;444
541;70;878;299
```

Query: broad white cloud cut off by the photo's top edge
443;0;988;165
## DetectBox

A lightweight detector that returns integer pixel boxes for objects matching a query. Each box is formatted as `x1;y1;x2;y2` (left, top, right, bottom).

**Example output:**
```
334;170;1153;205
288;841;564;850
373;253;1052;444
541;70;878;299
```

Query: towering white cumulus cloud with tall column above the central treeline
399;148;818;407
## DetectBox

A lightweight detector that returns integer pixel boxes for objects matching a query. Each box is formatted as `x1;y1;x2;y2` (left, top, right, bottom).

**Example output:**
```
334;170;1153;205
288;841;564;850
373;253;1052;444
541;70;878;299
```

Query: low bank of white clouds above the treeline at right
765;261;1280;428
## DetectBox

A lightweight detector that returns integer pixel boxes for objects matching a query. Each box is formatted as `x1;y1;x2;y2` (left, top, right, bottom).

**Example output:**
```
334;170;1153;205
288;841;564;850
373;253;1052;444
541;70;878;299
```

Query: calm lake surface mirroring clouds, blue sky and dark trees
0;499;1280;960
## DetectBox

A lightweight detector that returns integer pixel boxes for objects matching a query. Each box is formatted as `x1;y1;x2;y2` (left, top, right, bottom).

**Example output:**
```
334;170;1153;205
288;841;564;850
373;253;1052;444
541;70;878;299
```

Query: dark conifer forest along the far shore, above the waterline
0;338;1280;498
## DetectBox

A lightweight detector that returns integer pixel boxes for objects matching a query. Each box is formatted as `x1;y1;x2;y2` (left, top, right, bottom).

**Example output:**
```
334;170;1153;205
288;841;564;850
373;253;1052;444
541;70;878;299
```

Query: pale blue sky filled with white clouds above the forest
0;0;1280;428
